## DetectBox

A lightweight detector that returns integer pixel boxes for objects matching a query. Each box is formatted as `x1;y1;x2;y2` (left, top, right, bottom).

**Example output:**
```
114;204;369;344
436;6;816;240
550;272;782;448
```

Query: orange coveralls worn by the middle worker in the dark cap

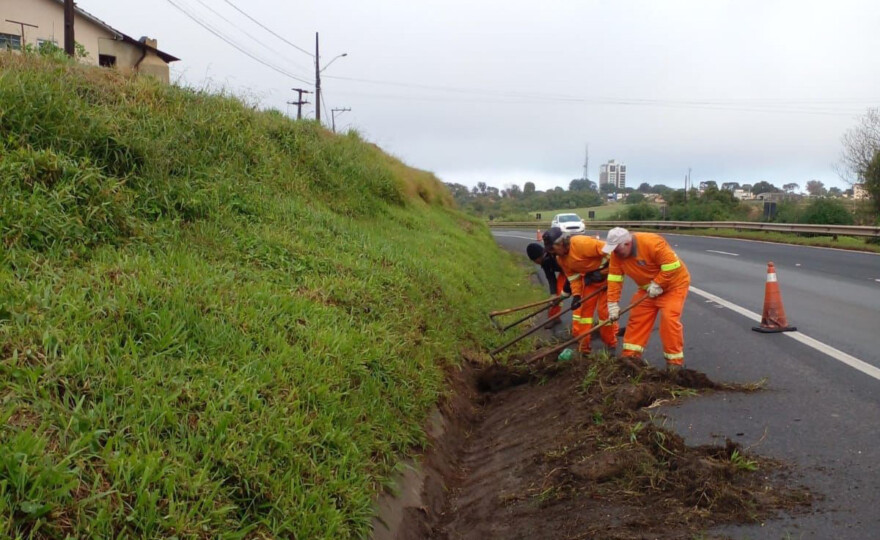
556;236;618;353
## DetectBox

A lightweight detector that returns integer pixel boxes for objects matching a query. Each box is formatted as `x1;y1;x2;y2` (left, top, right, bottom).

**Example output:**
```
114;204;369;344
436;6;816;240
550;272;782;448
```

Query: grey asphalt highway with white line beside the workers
493;229;880;539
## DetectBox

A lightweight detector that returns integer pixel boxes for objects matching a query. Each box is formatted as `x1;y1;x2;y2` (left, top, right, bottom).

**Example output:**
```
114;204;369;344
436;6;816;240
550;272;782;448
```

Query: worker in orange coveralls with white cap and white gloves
602;227;691;372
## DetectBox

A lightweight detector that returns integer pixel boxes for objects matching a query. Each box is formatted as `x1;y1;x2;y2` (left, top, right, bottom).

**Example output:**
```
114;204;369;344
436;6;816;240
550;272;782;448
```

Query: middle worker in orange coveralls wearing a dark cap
543;227;617;355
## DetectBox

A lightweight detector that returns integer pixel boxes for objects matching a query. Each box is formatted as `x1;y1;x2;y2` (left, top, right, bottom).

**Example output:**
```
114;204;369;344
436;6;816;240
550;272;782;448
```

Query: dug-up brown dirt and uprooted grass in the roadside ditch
384;352;812;539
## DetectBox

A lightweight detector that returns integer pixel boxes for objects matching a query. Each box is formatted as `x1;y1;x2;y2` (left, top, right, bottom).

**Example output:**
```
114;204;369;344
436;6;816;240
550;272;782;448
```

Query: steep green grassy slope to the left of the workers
0;54;536;538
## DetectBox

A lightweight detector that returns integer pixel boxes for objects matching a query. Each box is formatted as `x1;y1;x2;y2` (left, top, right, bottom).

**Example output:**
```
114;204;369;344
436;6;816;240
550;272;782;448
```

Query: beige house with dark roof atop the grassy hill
0;0;179;83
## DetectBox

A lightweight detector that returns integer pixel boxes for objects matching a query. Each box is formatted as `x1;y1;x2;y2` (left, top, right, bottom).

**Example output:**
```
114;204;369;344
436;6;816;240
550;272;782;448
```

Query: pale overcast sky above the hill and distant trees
77;0;880;189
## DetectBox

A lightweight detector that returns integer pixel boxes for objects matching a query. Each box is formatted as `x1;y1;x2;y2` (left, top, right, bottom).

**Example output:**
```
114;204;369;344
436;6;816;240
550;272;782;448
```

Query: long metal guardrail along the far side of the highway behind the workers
489;221;880;237
